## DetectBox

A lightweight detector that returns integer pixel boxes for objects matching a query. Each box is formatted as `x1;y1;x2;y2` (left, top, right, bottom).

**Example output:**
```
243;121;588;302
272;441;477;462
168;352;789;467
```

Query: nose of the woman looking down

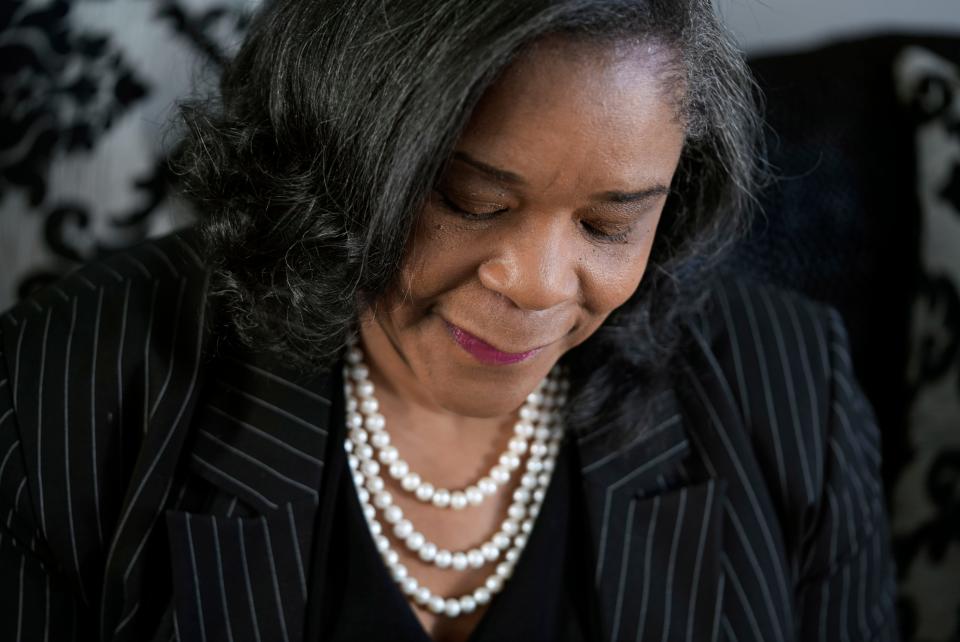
478;217;580;311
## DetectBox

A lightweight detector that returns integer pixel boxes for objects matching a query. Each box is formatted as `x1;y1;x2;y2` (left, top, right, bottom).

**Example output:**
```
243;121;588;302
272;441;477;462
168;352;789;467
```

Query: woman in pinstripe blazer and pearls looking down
0;0;896;641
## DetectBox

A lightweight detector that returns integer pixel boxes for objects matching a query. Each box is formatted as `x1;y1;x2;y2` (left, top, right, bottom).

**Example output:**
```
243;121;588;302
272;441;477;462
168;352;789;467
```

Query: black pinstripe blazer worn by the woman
0;232;896;642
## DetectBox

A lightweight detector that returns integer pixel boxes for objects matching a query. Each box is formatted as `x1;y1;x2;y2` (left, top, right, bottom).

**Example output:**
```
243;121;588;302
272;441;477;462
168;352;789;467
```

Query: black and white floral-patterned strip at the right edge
892;47;960;640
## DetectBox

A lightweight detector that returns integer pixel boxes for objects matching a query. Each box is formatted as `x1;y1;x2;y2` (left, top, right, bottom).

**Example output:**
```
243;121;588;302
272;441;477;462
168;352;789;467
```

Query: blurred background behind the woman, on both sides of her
0;0;960;641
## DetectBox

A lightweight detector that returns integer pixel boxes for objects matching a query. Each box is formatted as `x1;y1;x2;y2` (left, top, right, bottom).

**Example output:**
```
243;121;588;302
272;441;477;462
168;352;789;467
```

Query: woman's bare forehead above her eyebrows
458;37;683;189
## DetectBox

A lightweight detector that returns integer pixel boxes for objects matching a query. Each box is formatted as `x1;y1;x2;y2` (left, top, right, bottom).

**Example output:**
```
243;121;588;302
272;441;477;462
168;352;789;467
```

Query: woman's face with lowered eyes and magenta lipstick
361;39;684;417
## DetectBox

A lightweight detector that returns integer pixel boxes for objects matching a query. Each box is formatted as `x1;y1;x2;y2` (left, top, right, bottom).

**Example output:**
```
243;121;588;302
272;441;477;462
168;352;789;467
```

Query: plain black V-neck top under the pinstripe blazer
315;402;597;642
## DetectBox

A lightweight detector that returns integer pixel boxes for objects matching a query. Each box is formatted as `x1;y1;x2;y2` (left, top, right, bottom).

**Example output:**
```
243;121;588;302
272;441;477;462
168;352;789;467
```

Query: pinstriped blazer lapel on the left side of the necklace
166;354;331;642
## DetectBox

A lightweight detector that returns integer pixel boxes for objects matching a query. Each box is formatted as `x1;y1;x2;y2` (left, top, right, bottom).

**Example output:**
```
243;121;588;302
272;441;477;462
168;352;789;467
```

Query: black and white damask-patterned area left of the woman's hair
0;0;254;309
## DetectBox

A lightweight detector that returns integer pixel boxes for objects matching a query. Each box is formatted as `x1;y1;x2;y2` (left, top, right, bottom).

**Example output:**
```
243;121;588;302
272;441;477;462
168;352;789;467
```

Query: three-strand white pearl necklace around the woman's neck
344;343;567;617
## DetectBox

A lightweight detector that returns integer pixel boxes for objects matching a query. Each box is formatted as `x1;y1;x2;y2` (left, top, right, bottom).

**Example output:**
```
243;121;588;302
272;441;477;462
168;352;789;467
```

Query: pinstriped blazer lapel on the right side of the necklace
578;390;725;642
